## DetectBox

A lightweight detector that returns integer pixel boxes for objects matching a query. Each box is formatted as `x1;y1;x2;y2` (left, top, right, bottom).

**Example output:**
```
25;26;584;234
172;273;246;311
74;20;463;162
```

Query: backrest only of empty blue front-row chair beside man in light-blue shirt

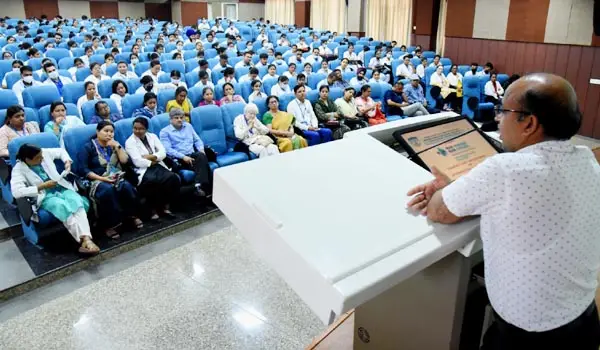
192;105;227;154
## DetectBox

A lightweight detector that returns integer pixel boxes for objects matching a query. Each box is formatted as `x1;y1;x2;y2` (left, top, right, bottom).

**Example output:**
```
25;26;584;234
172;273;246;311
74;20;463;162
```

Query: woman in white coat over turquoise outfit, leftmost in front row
10;144;100;255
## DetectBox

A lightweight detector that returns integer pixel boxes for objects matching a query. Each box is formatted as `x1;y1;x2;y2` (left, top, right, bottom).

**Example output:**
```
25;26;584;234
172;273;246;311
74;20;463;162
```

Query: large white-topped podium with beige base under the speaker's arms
213;113;481;350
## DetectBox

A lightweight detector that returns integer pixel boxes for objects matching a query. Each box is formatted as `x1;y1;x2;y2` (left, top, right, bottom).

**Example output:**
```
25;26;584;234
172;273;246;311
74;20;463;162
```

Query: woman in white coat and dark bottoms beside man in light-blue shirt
125;117;180;220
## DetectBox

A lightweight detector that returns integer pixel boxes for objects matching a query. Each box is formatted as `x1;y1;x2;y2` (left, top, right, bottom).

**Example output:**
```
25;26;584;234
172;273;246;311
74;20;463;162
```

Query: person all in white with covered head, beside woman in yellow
233;103;279;158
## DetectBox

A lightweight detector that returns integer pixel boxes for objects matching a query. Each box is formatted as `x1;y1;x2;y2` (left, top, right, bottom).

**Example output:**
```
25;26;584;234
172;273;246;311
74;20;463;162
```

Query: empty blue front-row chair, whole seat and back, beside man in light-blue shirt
192;105;248;167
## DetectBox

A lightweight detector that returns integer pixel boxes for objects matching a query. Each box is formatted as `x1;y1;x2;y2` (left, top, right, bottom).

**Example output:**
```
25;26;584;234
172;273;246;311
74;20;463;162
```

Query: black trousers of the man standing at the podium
481;302;600;350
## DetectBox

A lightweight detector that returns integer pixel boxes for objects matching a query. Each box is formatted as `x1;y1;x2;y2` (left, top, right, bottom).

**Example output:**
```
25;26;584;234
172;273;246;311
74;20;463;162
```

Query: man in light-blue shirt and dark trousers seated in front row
160;108;212;197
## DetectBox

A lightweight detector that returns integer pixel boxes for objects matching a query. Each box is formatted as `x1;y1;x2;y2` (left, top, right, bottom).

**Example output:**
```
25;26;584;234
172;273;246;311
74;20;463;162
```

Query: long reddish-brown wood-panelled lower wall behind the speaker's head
445;37;600;138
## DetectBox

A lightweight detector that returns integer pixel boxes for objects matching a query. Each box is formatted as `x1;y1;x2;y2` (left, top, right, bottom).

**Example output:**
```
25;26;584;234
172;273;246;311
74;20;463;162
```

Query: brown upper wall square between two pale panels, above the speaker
506;0;550;42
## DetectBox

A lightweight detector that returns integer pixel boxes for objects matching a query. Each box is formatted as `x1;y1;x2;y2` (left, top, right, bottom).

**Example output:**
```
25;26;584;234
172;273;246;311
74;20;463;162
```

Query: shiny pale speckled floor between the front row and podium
0;218;326;350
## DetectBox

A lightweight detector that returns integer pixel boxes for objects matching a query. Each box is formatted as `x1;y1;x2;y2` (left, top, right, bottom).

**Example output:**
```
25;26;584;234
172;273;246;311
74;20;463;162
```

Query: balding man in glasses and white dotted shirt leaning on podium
408;74;600;350
